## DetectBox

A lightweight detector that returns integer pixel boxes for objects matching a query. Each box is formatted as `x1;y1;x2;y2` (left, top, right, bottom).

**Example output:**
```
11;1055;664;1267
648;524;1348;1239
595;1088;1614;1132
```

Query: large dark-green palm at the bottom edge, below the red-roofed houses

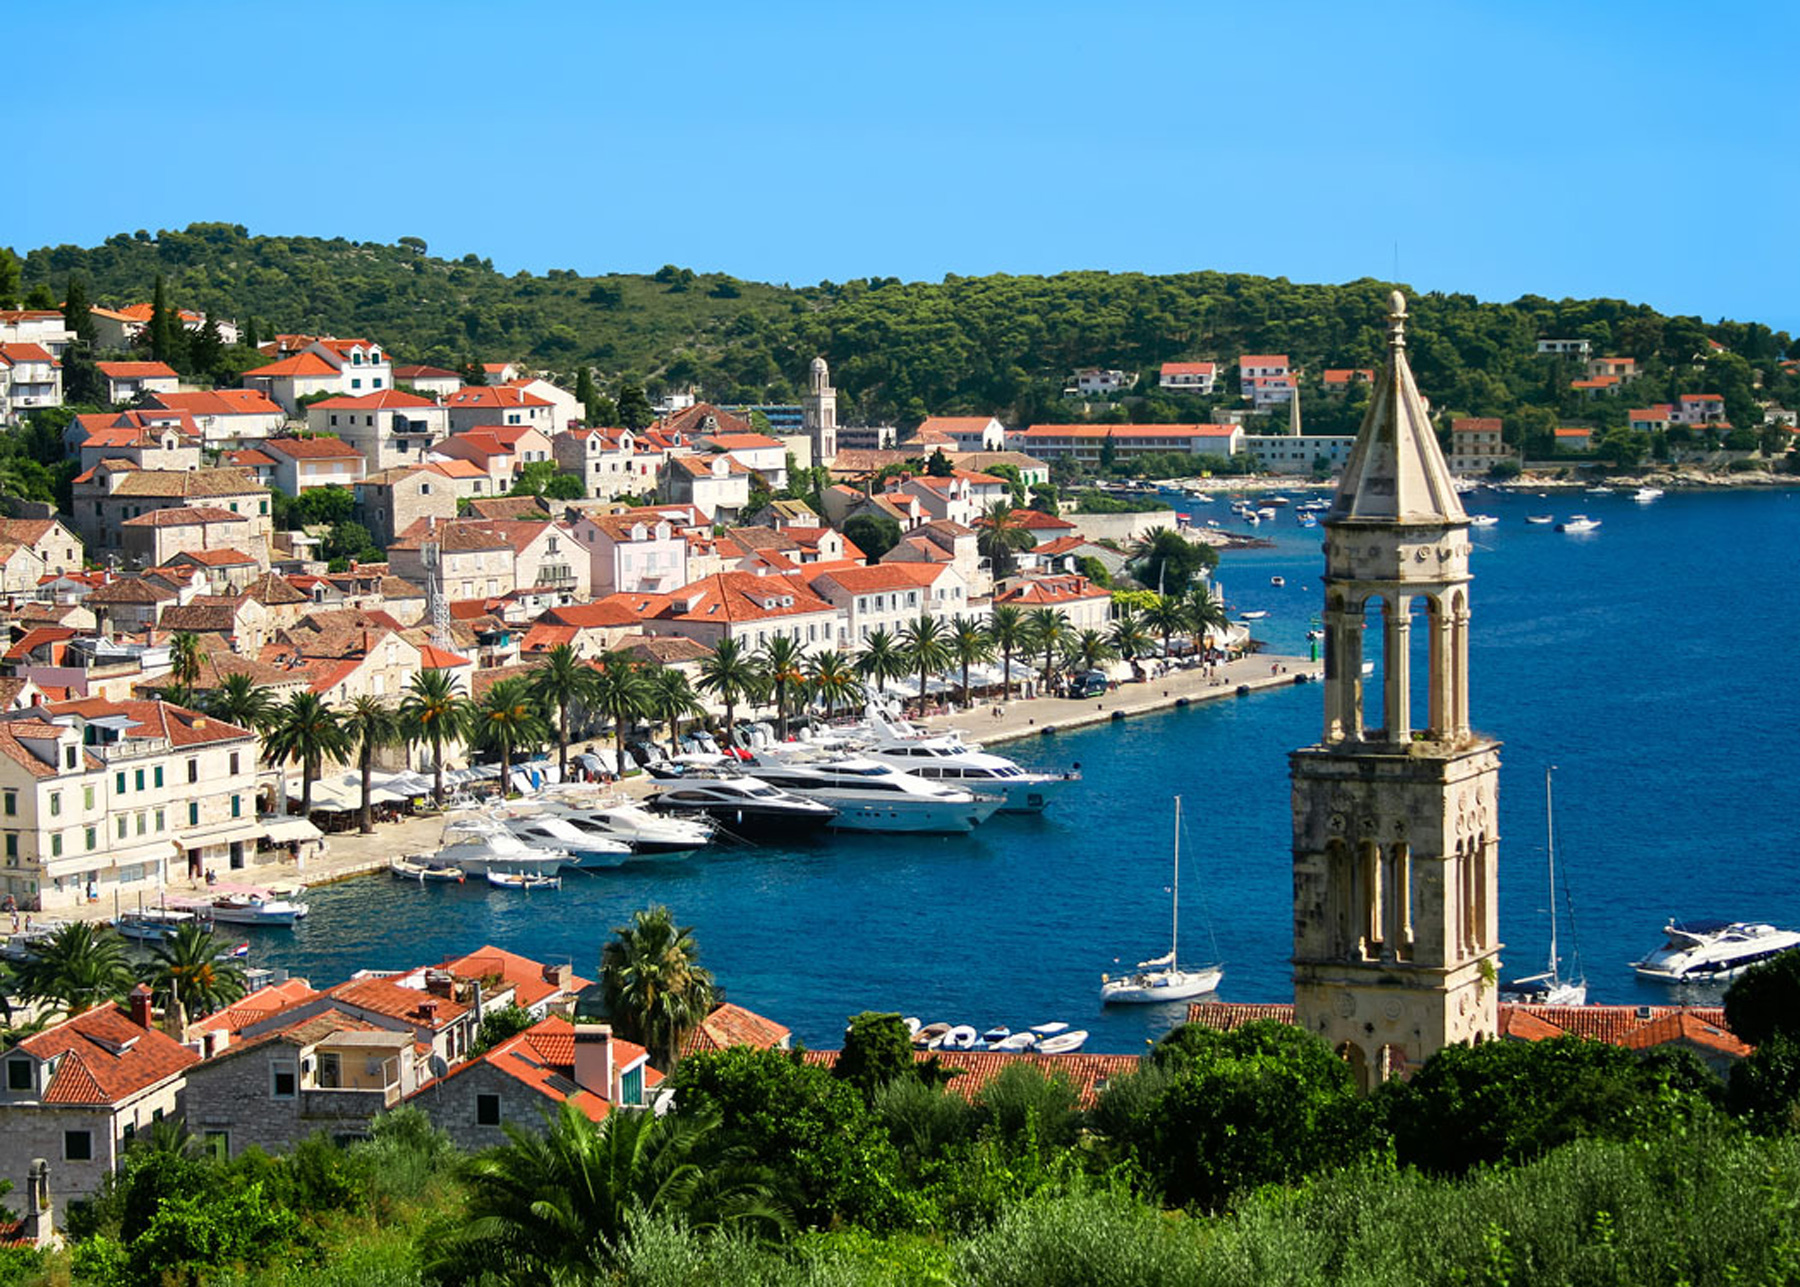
432;1098;788;1283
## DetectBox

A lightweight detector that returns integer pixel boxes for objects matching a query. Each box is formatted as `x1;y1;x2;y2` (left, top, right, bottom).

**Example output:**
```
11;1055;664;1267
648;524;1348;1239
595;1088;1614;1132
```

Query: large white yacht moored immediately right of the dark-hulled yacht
751;751;1001;833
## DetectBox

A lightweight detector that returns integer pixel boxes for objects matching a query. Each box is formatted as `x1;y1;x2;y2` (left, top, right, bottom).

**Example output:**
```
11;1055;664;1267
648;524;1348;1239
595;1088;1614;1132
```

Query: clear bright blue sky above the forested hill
14;0;1800;329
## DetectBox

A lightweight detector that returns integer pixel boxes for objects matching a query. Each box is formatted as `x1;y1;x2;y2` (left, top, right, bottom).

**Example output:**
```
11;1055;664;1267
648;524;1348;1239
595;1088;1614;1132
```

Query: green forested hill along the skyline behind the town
0;223;1795;436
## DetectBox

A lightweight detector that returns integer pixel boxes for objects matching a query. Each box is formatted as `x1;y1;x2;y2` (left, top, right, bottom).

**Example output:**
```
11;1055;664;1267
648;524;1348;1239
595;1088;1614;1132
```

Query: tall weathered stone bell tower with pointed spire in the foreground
1289;292;1499;1087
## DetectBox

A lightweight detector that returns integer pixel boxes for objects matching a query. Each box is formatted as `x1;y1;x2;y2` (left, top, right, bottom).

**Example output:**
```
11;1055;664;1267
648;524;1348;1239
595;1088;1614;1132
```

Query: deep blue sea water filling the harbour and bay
252;491;1800;1051
